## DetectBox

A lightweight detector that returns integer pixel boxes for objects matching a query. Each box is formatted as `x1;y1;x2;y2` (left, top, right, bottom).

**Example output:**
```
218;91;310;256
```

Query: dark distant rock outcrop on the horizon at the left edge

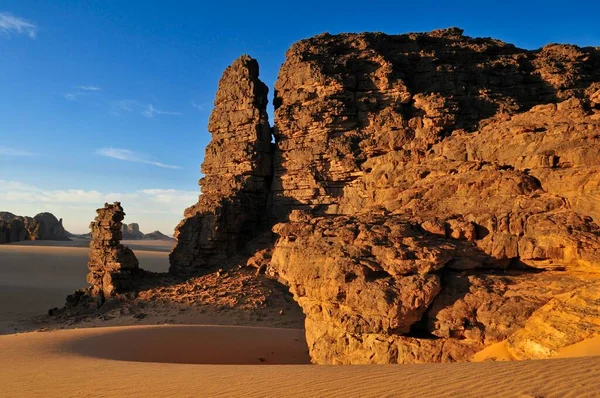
0;212;69;243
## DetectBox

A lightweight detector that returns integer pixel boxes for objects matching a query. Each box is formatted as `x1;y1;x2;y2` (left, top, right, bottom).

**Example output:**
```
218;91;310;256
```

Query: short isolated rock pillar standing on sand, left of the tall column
87;202;140;303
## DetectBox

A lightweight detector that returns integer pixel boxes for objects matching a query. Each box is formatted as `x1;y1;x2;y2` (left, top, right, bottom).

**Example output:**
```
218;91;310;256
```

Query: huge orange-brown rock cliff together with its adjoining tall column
171;28;600;363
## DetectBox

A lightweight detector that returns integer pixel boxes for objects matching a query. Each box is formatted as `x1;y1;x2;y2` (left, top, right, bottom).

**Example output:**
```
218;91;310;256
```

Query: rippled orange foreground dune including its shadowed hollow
0;326;600;398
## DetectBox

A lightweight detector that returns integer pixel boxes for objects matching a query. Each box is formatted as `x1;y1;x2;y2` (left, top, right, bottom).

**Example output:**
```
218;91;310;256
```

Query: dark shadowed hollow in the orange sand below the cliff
65;325;310;365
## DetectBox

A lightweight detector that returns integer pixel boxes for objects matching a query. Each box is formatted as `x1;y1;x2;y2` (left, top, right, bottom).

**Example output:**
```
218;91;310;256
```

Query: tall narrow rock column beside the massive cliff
169;55;272;274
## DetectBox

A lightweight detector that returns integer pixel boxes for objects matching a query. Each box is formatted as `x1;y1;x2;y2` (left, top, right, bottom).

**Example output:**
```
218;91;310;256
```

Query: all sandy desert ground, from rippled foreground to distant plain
0;242;600;398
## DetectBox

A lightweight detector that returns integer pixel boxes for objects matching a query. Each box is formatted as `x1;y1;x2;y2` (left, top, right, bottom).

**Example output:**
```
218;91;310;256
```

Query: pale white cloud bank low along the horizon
0;180;199;235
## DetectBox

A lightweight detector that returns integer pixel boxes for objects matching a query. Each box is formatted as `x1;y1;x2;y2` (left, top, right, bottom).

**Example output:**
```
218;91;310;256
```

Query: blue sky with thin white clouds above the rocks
0;0;600;233
